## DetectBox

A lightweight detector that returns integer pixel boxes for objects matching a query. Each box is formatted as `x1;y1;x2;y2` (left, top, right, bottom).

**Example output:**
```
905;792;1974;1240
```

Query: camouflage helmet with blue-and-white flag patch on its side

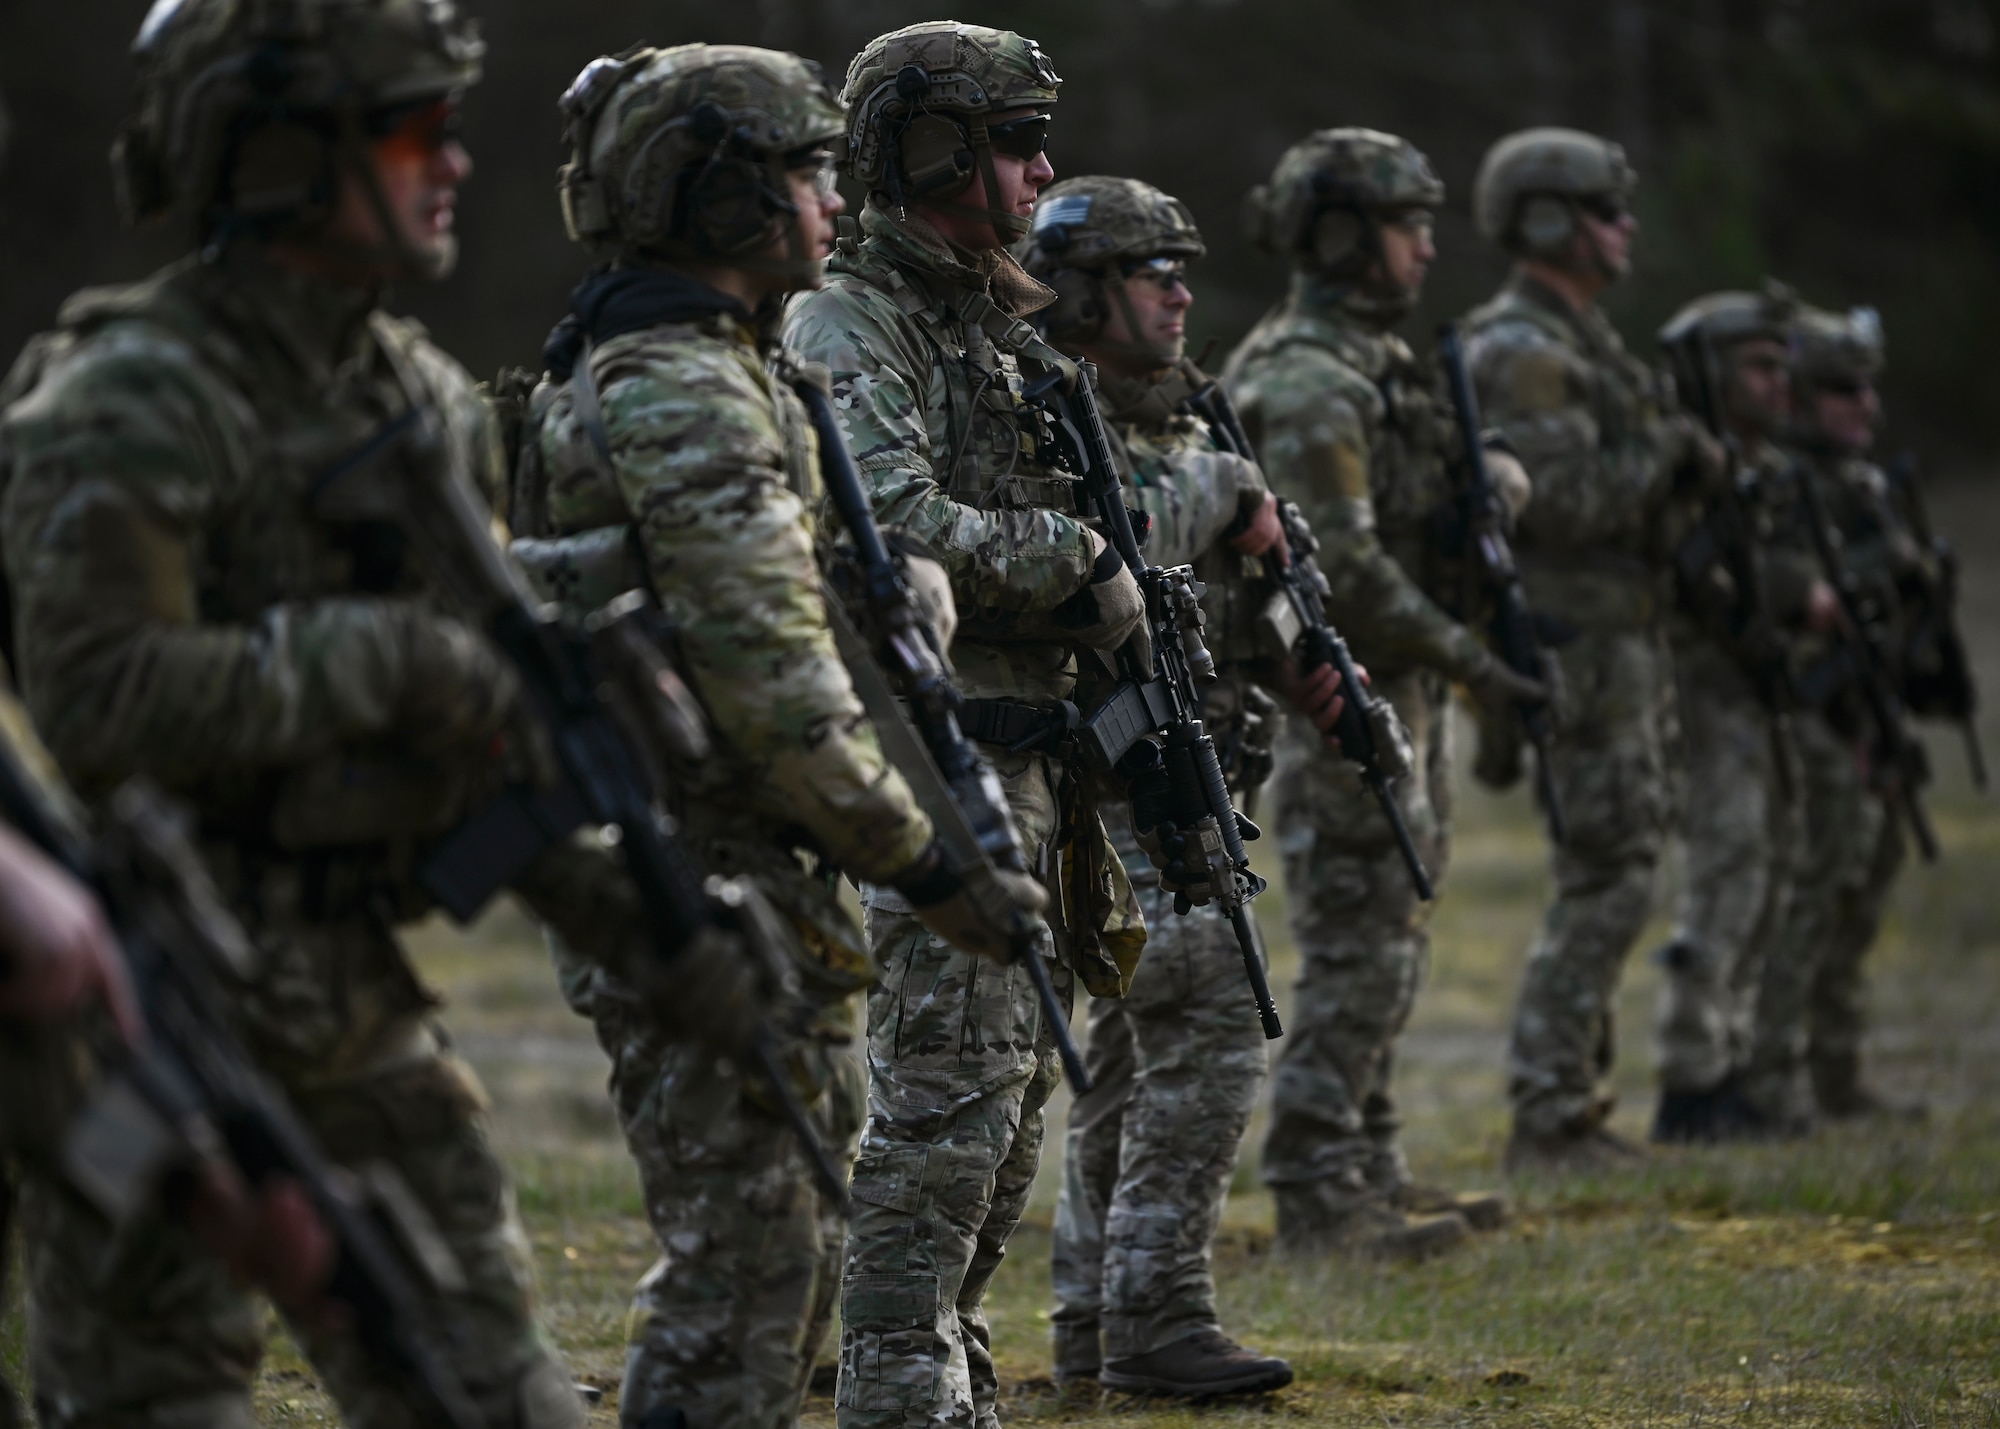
1014;174;1208;366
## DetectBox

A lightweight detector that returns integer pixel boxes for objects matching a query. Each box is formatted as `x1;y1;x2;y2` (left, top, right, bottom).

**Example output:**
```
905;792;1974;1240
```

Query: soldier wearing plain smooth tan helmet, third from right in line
1466;130;1720;1167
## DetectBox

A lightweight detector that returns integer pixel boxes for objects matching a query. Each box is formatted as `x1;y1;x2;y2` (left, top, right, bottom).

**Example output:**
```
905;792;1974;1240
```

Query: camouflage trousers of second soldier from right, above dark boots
1656;640;1800;1093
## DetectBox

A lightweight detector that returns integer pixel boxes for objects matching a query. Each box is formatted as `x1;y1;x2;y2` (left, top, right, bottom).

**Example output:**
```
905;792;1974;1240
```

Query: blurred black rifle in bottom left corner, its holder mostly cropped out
0;751;486;1429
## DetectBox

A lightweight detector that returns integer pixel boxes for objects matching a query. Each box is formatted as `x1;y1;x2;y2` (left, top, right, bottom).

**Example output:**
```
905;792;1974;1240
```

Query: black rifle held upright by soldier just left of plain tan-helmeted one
1438;322;1568;845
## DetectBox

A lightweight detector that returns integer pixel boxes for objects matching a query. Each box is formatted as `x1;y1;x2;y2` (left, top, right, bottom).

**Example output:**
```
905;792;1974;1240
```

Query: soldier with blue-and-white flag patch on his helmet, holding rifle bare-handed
1020;178;1292;1395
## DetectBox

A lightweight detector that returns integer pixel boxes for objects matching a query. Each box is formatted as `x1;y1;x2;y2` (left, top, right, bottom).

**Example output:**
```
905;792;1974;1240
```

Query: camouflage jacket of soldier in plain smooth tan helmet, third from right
1464;274;1670;628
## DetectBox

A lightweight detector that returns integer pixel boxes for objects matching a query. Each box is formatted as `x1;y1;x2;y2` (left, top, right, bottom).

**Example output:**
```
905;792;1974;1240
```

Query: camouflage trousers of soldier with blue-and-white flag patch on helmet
1052;824;1264;1373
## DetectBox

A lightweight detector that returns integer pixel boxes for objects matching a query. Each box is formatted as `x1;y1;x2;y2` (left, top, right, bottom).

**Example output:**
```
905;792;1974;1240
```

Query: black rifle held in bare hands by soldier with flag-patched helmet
1188;372;1436;903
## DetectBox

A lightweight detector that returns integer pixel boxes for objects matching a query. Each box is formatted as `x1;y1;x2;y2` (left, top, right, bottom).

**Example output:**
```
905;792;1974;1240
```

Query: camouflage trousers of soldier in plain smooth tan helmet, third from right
1508;628;1678;1137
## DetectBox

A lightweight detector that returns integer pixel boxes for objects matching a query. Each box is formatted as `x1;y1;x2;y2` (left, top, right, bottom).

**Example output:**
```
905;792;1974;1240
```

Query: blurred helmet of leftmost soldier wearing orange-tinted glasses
112;0;486;270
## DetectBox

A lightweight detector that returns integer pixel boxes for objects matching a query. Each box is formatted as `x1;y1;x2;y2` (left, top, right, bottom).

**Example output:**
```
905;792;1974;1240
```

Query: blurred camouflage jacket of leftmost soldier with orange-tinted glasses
0;248;540;917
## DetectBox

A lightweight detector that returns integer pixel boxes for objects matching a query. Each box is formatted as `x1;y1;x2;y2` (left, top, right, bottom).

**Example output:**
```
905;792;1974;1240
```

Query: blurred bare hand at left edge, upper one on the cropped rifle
0;825;144;1041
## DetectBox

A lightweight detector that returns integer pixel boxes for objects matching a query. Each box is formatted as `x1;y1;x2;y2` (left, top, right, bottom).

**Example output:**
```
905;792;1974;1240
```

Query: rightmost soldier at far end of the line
1744;308;1938;1133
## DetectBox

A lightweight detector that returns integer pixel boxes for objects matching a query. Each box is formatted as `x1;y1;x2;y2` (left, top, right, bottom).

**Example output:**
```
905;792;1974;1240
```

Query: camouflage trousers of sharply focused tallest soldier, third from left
836;749;1072;1429
